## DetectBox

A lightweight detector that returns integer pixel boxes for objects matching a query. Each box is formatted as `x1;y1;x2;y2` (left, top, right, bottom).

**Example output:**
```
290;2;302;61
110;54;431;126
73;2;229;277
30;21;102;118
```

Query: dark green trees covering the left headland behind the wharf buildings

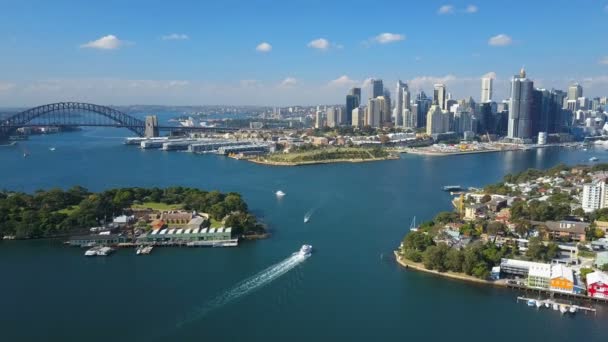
0;186;264;238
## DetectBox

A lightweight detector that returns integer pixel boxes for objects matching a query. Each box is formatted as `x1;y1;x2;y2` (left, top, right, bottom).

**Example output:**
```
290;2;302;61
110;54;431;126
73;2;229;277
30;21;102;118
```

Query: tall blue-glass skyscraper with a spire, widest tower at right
507;68;534;139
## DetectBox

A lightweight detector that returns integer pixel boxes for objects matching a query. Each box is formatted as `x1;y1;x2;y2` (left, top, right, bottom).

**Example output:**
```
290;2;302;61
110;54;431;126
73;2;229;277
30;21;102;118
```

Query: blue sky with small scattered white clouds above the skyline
0;0;608;107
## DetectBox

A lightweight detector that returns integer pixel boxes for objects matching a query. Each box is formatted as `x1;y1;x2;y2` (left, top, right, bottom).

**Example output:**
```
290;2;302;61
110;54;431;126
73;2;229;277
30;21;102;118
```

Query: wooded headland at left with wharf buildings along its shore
0;186;266;243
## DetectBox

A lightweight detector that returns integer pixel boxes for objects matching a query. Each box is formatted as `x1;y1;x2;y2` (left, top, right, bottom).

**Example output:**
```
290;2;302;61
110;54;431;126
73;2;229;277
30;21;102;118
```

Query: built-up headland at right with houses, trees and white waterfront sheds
395;164;608;300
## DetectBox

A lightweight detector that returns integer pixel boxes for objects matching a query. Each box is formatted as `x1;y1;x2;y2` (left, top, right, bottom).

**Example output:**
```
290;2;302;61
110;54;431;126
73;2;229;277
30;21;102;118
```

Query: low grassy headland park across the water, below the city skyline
251;145;399;166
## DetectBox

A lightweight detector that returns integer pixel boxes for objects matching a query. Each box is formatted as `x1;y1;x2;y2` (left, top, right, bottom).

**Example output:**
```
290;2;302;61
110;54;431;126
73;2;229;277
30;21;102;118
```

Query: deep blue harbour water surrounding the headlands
0;129;608;342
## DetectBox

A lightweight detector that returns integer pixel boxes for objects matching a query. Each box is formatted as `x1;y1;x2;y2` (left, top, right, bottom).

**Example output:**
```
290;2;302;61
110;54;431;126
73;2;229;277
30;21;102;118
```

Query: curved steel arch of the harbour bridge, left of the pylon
0;102;145;138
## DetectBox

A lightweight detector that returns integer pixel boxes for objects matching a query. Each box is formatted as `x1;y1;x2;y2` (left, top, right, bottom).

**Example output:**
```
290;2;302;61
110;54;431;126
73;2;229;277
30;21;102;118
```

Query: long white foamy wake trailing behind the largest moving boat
176;252;310;328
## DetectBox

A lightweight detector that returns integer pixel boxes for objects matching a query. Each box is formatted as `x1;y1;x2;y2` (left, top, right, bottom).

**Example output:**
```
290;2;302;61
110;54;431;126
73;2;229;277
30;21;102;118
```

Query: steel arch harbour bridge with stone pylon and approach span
0;102;238;140
